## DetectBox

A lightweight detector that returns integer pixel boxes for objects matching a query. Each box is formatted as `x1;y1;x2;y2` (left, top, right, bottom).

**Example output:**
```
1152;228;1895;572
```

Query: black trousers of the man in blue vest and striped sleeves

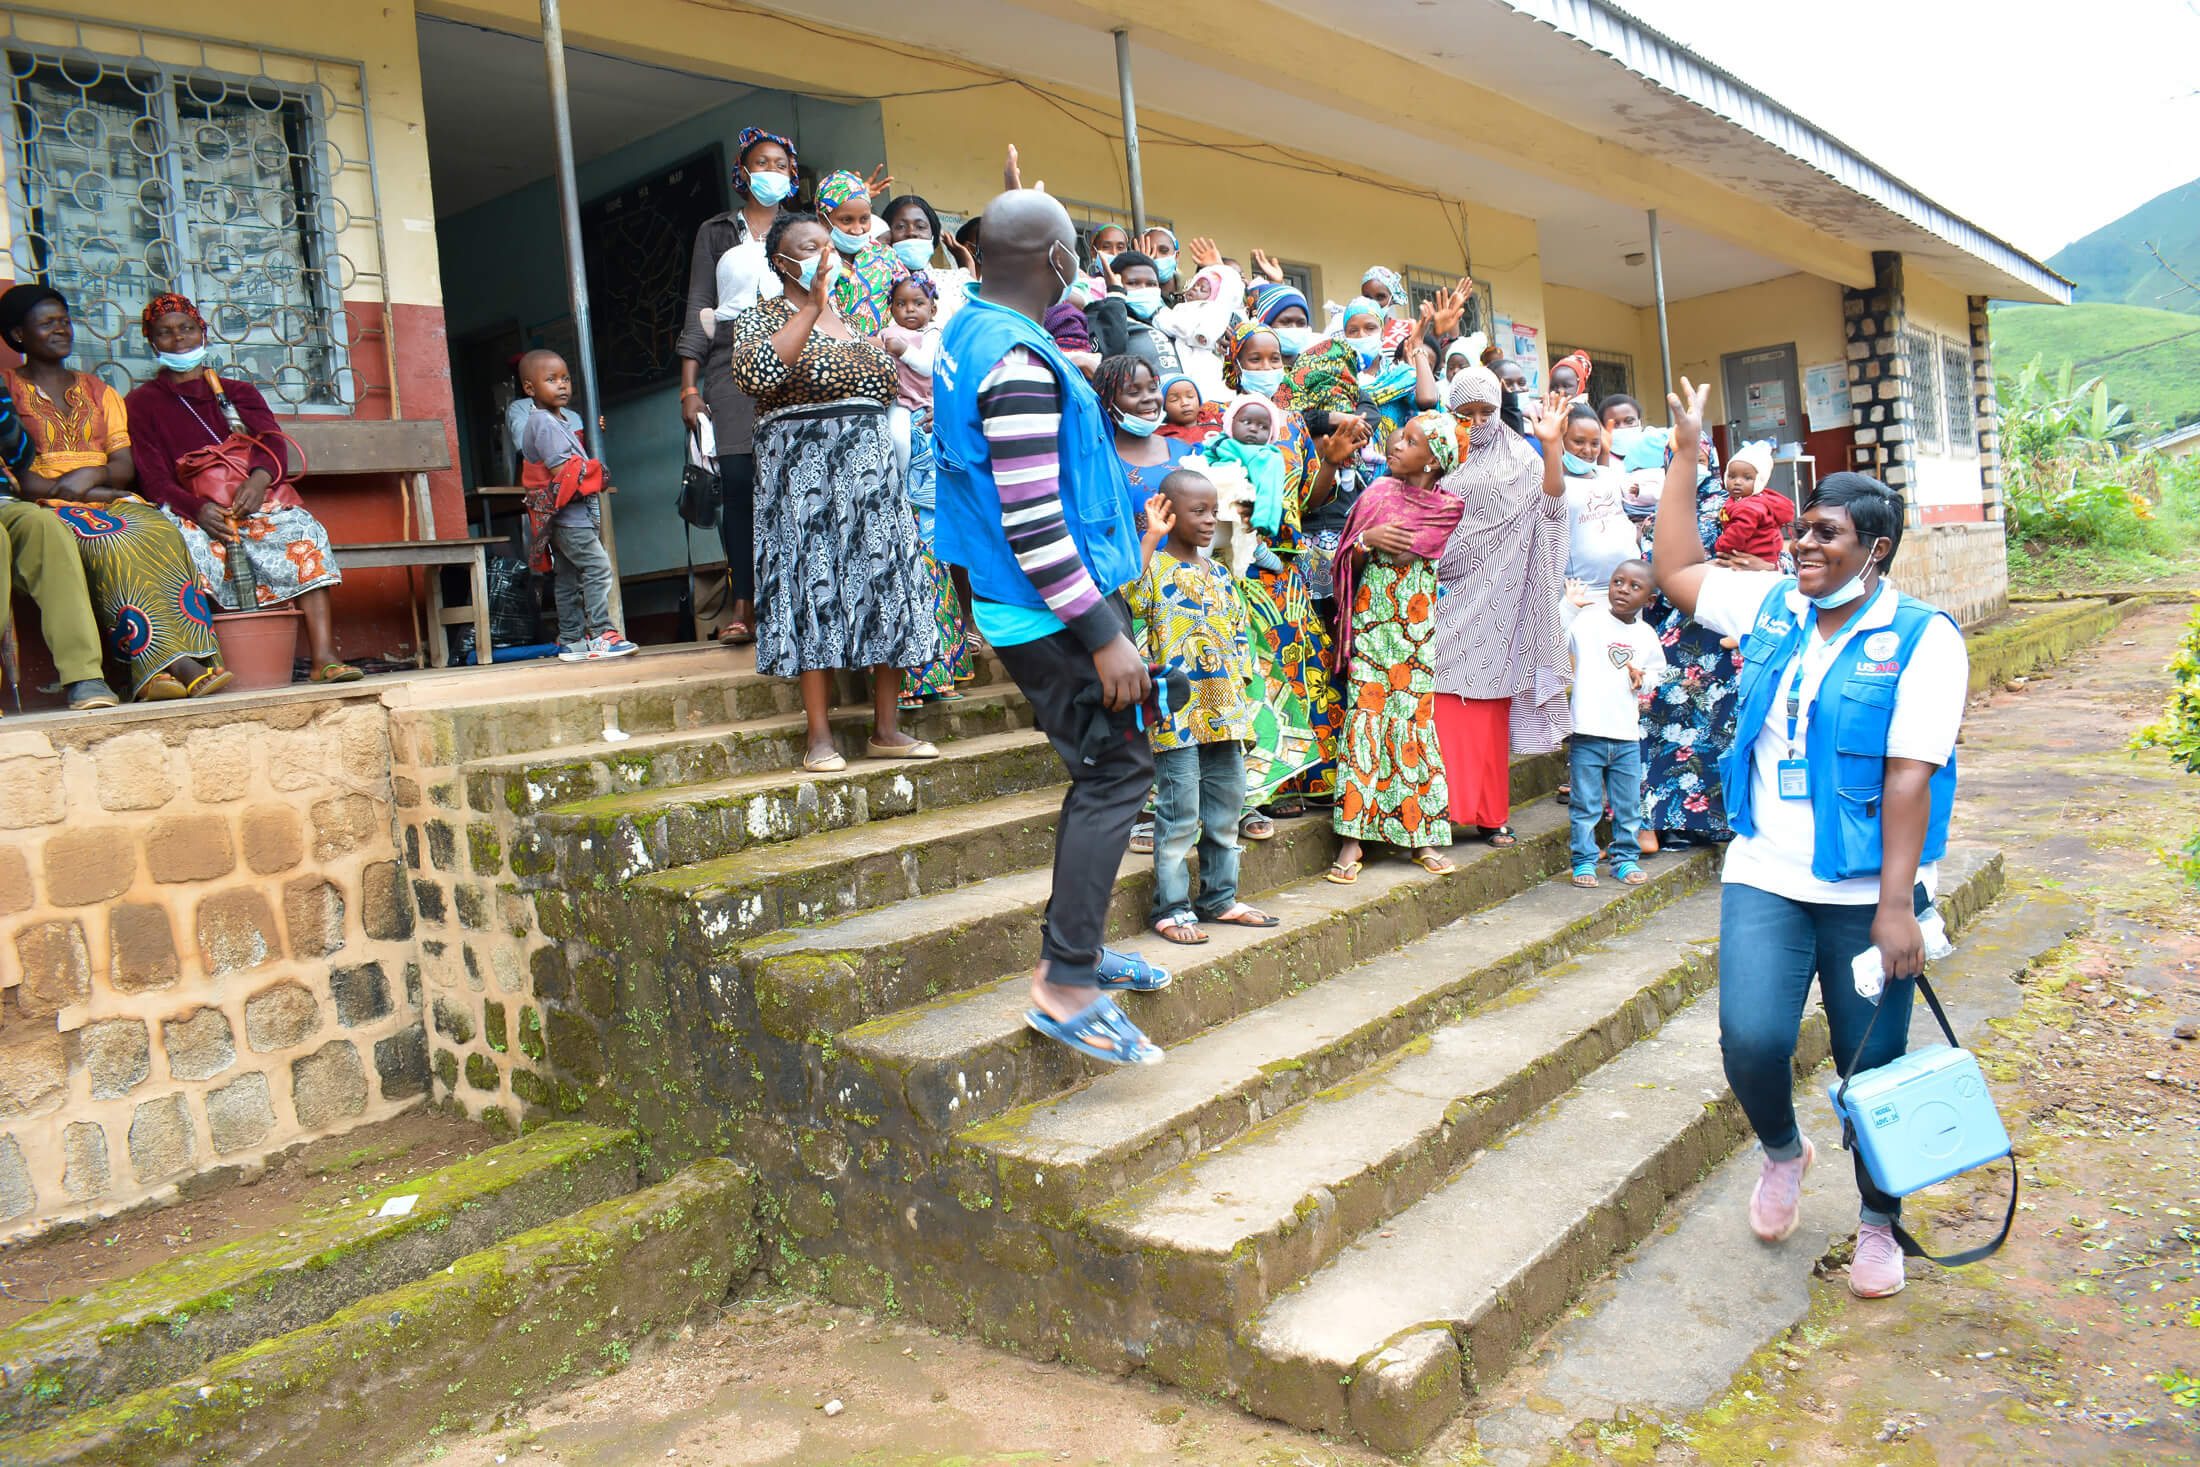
994;600;1153;988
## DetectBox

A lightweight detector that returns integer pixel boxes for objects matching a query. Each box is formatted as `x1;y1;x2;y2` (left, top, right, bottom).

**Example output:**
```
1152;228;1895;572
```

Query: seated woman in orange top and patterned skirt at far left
0;284;229;704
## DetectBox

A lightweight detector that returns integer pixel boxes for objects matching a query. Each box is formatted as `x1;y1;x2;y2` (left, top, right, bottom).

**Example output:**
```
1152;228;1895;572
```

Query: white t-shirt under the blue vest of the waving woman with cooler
1696;565;1971;906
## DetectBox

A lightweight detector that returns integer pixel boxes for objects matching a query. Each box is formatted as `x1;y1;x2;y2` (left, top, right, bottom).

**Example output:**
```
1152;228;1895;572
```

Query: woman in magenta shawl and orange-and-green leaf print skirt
1329;413;1463;886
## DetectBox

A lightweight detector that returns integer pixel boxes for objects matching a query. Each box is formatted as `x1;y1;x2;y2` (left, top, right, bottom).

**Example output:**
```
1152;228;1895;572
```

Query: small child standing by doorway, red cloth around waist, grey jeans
519;350;640;662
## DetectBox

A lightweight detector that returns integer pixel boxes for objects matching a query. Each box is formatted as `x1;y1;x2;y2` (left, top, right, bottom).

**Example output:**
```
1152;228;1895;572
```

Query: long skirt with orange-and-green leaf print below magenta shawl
1335;556;1452;849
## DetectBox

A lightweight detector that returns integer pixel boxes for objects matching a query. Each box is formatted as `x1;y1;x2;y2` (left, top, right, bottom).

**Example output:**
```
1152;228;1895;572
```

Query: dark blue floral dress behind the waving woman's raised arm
1641;477;1742;840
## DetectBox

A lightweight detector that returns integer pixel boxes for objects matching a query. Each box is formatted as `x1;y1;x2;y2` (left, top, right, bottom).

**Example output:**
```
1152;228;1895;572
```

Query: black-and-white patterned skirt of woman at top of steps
757;398;939;677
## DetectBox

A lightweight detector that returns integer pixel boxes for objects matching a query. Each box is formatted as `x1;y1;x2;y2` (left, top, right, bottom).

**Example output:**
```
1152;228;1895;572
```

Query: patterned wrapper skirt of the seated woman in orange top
46;499;220;695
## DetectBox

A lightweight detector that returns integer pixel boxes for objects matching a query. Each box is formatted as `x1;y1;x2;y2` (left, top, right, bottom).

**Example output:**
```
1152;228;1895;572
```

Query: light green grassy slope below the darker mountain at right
1993;299;2200;429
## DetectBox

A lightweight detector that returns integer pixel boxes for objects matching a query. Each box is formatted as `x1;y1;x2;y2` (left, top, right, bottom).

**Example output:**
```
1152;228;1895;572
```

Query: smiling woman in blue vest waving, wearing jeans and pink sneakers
1652;378;1969;1298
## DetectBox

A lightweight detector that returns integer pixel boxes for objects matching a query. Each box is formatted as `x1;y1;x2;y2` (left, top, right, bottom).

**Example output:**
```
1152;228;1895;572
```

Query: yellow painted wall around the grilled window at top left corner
0;0;442;306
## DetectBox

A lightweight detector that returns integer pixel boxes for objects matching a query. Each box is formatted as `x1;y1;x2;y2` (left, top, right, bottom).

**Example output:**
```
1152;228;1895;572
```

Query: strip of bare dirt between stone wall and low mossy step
0;1111;490;1326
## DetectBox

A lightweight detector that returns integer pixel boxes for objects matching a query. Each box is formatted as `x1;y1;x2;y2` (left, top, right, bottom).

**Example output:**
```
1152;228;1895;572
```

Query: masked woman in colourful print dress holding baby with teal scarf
1223;321;1342;816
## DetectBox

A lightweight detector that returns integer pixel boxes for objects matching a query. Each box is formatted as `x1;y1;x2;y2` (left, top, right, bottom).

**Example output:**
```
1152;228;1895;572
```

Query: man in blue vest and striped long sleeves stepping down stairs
933;147;1168;1065
